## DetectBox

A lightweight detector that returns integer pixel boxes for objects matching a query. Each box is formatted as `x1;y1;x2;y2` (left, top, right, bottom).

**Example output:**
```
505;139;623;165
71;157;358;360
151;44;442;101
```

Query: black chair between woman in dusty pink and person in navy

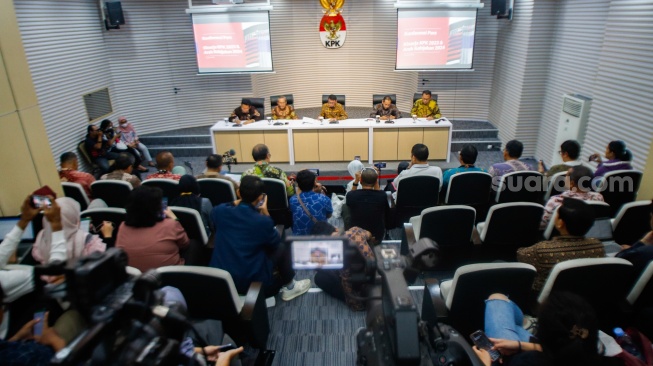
170;206;211;266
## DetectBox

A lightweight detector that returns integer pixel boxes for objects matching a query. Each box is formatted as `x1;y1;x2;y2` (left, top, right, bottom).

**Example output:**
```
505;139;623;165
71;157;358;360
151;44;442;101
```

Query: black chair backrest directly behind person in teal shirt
444;172;492;205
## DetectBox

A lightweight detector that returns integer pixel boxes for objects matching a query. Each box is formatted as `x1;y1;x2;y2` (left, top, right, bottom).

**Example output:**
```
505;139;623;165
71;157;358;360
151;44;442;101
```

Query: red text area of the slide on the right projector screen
397;17;449;68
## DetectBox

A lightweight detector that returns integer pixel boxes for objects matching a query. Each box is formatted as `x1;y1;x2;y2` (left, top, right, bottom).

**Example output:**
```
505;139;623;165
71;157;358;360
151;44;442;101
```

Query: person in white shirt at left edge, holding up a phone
0;197;66;303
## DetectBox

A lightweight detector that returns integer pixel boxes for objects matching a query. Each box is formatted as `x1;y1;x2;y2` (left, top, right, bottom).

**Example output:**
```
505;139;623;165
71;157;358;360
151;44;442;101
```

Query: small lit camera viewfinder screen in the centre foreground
291;240;344;269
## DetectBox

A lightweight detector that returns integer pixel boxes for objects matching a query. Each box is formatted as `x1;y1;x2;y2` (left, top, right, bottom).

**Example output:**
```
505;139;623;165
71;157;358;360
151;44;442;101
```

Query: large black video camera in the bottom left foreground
34;248;202;366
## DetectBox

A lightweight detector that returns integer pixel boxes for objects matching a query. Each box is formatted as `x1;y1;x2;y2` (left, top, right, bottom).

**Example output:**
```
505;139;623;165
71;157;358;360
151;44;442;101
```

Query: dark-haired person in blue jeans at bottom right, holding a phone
473;292;621;366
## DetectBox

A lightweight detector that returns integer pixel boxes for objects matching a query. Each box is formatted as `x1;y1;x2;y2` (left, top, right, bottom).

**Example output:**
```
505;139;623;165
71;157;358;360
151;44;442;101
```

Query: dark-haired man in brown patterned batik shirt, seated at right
517;197;605;292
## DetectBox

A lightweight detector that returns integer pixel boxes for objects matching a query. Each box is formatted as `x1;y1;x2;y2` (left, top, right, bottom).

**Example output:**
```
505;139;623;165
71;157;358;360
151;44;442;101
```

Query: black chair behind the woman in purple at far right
598;170;642;217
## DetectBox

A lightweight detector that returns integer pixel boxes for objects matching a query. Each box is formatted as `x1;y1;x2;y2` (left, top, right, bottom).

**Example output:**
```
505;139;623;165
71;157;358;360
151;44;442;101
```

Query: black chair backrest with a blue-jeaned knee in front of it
445;263;536;334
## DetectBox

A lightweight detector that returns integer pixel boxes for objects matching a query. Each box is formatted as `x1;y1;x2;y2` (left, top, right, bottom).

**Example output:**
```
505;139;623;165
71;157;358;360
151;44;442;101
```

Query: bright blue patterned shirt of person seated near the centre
290;191;333;235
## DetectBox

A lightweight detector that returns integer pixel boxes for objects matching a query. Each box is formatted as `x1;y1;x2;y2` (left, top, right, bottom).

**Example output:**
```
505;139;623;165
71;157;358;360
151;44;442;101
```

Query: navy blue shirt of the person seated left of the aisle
209;202;281;294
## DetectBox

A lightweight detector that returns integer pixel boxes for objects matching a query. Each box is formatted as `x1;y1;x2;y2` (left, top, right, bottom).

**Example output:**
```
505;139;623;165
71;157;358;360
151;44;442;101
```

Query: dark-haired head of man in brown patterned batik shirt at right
555;197;594;236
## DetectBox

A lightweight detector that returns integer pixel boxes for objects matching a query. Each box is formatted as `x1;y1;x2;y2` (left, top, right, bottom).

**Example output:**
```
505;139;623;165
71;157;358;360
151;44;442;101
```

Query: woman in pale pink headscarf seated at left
32;197;107;263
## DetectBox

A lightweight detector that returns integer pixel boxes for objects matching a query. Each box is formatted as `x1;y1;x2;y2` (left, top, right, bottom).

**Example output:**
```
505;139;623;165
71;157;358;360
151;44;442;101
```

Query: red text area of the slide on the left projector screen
193;23;247;70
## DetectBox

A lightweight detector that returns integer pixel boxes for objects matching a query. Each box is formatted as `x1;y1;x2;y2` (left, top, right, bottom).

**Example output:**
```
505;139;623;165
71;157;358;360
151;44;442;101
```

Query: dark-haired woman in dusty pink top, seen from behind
116;185;190;272
